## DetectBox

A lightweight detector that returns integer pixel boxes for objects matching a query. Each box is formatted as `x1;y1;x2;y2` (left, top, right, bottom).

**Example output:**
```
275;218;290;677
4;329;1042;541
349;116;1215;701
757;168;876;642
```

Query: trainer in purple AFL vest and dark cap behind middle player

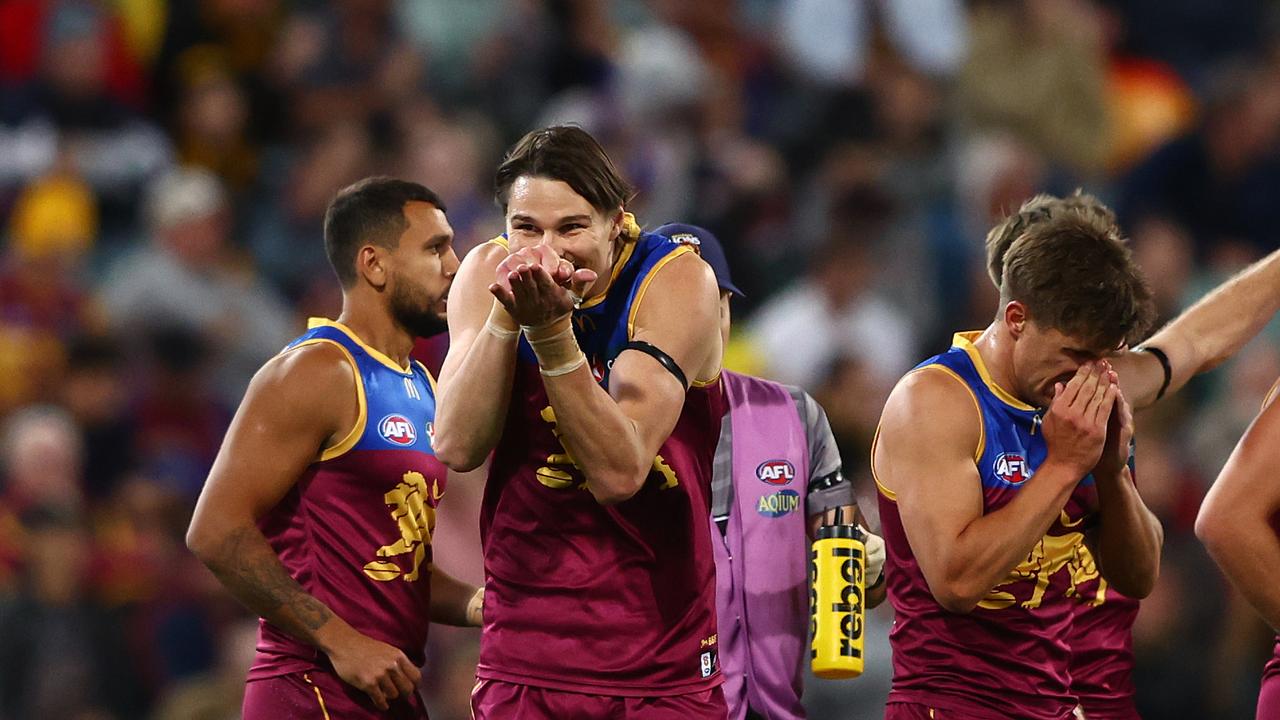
655;224;883;720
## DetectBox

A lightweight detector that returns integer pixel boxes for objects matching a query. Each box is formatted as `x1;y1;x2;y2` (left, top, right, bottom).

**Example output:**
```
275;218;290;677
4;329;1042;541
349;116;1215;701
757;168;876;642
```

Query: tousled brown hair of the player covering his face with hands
1000;213;1155;352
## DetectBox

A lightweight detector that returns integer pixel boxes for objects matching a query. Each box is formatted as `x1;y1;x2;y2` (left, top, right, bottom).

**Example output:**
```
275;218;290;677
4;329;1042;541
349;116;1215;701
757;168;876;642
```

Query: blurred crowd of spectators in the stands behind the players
0;0;1280;720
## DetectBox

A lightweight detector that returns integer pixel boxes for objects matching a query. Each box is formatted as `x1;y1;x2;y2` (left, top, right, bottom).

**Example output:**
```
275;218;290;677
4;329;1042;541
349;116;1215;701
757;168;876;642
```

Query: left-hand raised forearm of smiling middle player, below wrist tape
433;304;518;471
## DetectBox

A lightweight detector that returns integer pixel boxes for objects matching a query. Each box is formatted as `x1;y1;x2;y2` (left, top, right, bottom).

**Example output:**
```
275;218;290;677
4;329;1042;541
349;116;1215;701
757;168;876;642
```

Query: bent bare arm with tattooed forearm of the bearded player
187;343;420;710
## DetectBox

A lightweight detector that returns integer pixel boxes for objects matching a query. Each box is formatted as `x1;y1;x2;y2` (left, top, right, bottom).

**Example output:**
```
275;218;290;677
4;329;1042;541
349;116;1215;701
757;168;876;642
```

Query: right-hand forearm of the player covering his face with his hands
1094;468;1165;600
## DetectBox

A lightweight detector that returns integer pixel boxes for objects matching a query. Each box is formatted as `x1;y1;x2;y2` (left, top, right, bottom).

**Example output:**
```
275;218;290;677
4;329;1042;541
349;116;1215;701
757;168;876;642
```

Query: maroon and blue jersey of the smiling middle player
476;233;724;696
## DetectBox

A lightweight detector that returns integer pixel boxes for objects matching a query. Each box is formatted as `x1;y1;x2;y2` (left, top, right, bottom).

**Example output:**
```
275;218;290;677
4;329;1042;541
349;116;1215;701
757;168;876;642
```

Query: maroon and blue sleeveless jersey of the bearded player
248;320;445;680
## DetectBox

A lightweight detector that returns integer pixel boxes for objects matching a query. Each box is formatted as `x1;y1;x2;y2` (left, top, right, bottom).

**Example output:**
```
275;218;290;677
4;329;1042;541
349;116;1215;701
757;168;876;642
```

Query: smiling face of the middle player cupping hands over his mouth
507;176;622;297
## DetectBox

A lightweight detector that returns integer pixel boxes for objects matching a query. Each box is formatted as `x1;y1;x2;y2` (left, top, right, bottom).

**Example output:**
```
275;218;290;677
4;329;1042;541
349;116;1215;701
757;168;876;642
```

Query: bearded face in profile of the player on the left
384;200;458;337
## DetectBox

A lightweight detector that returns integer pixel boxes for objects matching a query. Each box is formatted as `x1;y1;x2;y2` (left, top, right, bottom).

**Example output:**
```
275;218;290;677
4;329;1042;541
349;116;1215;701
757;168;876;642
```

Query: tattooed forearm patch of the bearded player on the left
210;528;333;635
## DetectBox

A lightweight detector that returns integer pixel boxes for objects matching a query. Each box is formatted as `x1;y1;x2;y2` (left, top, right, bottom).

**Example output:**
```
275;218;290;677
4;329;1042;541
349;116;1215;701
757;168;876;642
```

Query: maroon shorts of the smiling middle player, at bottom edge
473;680;728;720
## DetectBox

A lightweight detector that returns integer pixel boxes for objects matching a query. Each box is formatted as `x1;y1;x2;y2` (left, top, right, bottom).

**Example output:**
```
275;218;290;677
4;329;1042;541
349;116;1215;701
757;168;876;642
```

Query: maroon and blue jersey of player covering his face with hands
873;333;1097;720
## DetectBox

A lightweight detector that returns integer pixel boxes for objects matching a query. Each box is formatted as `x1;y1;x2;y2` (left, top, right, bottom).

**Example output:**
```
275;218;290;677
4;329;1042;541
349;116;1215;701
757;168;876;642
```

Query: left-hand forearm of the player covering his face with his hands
927;462;1079;612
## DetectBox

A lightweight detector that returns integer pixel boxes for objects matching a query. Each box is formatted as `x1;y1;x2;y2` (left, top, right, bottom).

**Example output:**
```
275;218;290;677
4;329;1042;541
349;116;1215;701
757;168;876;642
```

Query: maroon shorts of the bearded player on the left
242;670;426;720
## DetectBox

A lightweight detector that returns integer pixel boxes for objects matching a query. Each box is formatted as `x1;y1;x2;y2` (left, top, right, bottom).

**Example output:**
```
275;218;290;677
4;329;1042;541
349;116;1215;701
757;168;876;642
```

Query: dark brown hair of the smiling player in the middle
494;126;635;213
